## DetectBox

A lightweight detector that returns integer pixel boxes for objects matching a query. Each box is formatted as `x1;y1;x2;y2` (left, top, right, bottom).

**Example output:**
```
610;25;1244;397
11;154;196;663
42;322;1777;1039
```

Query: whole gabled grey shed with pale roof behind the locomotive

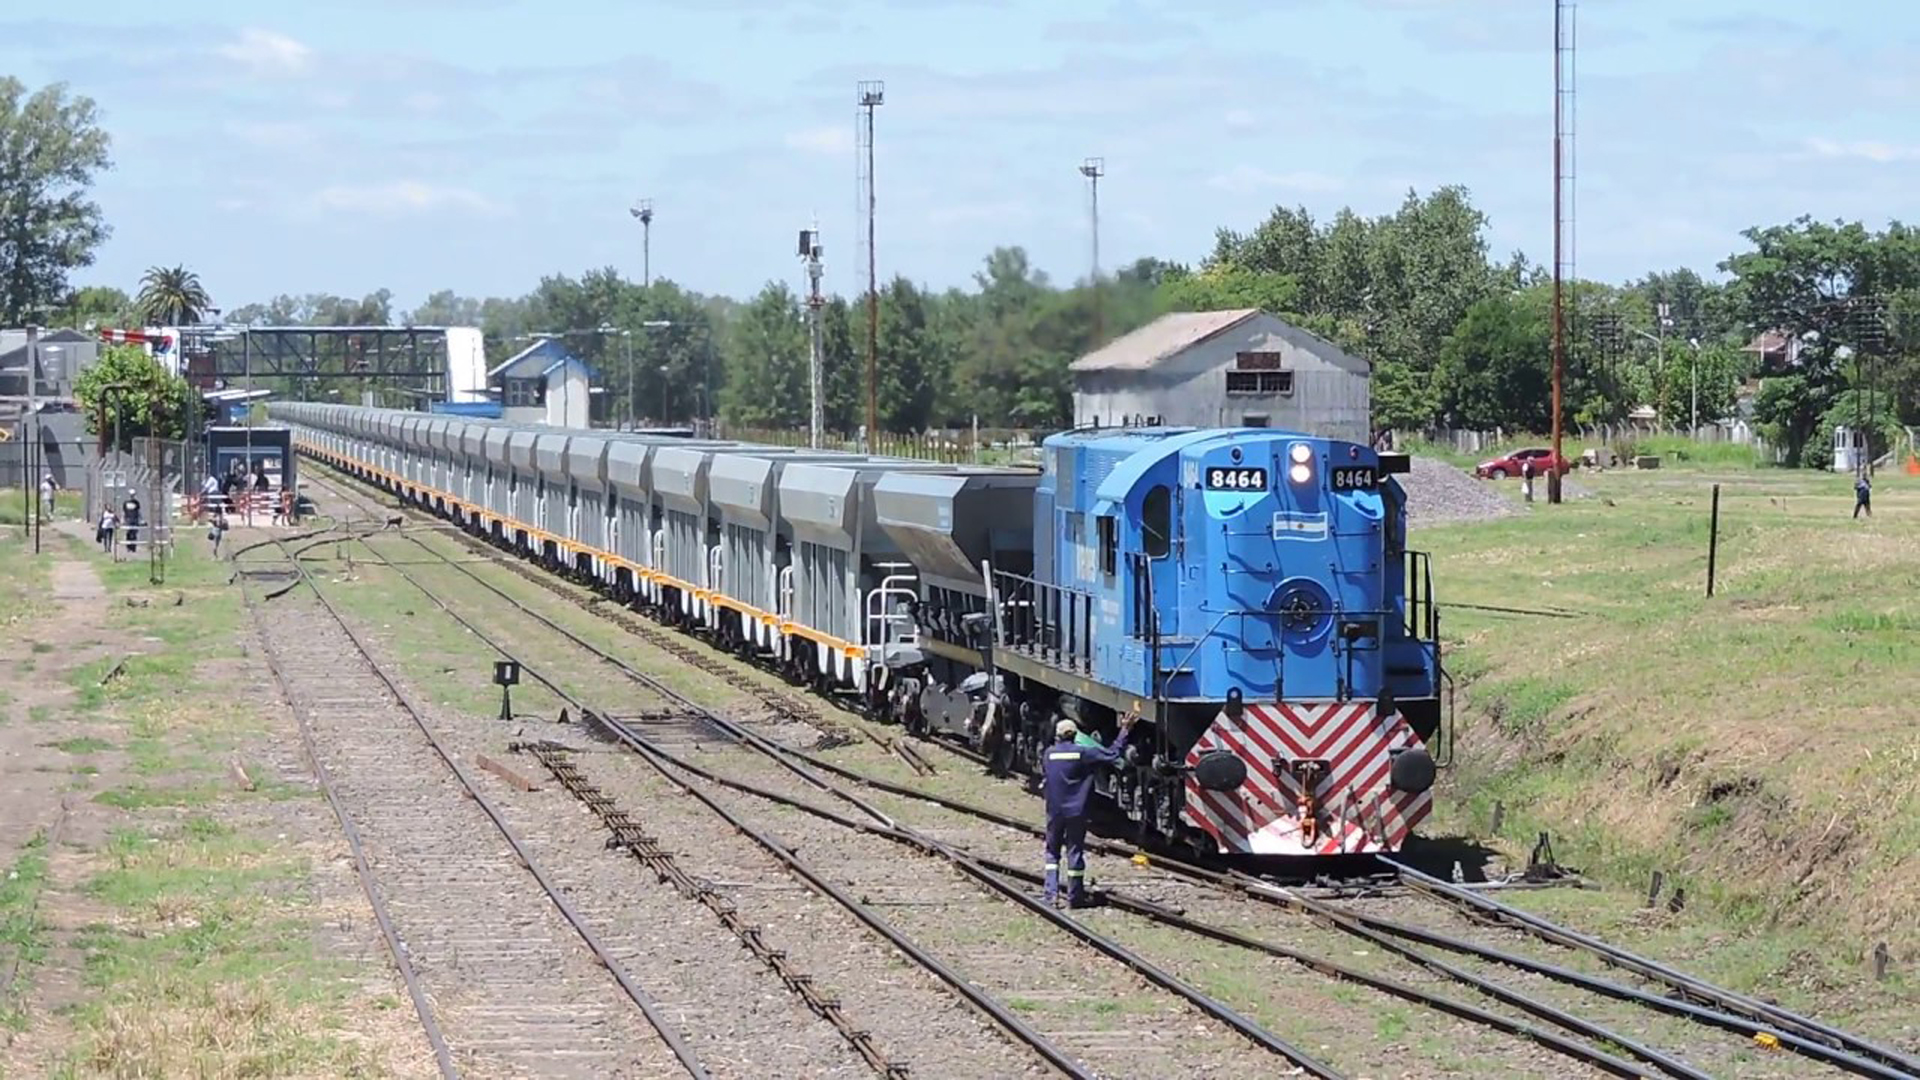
1071;307;1373;444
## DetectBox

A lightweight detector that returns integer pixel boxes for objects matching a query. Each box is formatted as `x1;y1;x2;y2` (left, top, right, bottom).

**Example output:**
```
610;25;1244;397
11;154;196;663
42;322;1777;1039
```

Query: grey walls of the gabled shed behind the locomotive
1073;317;1373;444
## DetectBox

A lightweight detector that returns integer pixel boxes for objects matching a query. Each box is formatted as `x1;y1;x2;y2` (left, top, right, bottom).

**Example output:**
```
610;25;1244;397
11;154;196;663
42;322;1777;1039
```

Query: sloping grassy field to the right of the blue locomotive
1415;469;1920;1006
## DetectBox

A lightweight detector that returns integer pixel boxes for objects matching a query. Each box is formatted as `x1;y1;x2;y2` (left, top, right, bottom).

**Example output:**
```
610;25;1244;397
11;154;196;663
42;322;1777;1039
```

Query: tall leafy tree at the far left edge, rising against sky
0;75;111;327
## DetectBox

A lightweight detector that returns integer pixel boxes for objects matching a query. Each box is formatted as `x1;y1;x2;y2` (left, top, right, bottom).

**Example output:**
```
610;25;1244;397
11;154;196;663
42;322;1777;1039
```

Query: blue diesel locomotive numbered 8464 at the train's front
881;429;1442;855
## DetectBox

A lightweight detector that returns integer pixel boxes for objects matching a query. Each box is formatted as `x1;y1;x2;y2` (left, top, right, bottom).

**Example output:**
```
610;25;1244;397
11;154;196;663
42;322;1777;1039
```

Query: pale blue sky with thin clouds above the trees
0;0;1920;309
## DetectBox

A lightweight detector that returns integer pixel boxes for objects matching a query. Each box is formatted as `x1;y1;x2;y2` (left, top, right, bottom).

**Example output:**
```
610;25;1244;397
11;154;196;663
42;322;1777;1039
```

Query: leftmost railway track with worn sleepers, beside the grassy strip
236;542;708;1080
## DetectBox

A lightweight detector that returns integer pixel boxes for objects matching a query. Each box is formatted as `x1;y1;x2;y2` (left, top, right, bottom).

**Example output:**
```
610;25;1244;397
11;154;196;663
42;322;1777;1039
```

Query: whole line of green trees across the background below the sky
0;79;1920;461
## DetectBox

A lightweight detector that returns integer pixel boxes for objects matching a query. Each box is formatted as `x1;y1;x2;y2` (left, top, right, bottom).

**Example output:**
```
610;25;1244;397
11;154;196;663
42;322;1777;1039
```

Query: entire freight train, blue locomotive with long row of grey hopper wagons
269;404;1444;855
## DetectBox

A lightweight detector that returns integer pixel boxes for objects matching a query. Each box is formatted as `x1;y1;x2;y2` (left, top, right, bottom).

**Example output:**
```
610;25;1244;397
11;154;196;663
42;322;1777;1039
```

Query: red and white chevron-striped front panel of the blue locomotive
1185;701;1432;855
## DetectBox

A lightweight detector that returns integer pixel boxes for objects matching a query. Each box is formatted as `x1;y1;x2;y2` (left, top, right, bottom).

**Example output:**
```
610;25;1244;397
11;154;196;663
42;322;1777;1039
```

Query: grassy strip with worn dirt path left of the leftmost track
0;525;430;1078
